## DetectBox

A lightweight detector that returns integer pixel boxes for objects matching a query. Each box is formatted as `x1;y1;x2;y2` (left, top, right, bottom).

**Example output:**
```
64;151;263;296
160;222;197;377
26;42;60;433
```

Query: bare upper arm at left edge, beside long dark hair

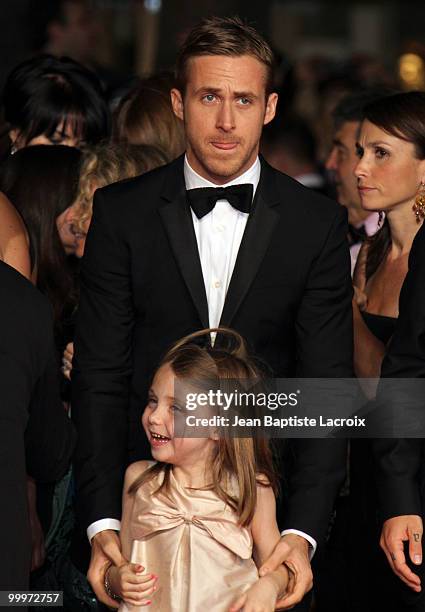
0;193;31;279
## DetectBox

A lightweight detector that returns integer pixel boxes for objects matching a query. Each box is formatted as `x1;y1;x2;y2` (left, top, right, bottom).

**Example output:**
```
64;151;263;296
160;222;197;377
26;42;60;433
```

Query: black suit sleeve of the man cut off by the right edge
373;220;425;520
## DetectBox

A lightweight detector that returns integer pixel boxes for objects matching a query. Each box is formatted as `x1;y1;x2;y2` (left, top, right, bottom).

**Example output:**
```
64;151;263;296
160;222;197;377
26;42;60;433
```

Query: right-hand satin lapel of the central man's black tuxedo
220;159;279;327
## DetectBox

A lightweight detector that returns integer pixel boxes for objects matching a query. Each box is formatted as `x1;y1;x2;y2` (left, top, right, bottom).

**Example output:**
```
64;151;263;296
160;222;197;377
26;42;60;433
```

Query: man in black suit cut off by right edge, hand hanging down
373;219;425;612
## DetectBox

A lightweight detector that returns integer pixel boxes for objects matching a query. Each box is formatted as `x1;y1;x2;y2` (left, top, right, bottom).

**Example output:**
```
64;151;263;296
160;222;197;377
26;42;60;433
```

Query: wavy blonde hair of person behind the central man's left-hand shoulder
74;144;167;232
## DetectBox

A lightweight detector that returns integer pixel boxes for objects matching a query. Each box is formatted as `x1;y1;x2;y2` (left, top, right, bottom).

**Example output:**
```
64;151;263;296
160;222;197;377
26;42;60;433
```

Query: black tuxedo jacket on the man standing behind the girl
73;157;352;541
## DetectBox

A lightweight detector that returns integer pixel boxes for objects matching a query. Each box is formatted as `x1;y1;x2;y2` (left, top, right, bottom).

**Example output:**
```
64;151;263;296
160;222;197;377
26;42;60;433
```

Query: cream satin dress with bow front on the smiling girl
119;472;258;612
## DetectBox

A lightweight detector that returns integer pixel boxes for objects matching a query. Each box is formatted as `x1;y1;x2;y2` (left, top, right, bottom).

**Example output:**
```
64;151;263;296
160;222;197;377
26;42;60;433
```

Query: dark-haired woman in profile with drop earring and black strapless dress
348;91;425;612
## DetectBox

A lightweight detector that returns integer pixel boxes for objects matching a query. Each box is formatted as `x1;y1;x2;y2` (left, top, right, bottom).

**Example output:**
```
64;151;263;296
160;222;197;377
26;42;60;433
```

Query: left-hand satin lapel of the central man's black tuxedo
159;157;209;328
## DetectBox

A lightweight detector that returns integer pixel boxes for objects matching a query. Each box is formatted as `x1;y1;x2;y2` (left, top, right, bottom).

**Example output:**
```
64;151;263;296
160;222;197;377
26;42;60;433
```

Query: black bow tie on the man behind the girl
187;183;254;219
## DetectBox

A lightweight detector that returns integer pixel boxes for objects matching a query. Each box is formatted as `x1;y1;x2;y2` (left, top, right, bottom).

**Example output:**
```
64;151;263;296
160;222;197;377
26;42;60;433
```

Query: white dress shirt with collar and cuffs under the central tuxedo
87;157;317;556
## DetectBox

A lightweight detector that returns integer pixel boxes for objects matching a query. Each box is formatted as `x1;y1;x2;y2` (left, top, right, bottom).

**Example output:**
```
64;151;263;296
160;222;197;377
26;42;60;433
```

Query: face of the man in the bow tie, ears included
171;55;277;185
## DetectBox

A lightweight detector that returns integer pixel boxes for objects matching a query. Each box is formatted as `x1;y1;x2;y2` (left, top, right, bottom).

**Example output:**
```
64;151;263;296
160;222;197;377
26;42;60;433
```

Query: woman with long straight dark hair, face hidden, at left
1;145;82;342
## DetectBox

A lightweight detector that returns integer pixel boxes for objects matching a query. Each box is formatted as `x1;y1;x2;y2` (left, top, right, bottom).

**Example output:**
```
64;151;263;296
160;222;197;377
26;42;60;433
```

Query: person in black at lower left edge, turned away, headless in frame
0;261;75;590
